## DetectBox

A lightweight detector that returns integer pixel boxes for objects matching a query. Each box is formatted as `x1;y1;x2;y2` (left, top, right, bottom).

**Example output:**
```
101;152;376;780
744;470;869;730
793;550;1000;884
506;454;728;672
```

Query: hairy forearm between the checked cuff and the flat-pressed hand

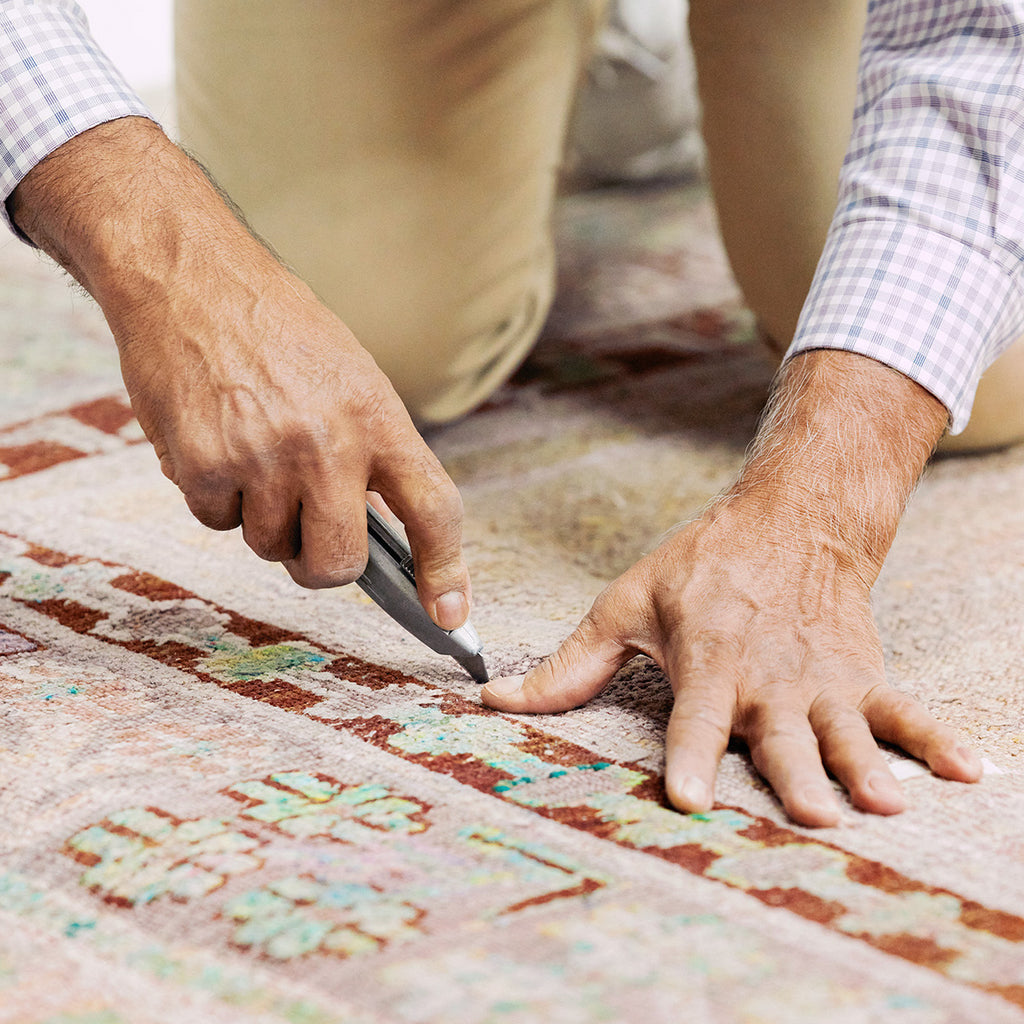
725;350;947;583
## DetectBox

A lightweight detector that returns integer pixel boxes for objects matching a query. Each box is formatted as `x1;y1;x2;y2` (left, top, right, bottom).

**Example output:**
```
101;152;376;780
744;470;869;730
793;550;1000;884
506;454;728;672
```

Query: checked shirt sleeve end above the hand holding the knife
0;0;151;237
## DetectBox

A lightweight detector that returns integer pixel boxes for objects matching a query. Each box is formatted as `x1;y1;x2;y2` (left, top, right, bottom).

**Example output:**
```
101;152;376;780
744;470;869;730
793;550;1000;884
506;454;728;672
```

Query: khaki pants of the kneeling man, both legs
175;0;1024;443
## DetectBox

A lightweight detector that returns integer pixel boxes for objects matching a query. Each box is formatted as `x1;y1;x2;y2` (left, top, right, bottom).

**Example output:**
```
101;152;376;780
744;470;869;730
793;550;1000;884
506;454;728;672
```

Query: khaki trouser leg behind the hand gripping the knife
175;0;603;422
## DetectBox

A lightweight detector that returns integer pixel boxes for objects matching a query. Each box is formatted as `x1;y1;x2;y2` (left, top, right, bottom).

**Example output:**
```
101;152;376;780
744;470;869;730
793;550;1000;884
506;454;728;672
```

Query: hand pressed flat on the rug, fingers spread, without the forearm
482;491;980;825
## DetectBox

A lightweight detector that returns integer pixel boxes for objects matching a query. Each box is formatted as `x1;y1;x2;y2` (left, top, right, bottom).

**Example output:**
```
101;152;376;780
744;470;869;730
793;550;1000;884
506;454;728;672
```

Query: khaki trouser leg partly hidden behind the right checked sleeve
690;0;1024;451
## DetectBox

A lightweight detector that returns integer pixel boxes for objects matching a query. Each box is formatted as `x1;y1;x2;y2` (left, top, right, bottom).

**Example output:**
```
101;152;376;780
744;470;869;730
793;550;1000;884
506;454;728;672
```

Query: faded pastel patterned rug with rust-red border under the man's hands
0;185;1024;1024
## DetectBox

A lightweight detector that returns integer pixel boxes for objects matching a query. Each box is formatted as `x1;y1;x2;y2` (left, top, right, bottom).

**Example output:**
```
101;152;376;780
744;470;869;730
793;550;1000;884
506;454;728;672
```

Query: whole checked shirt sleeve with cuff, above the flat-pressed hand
790;0;1024;433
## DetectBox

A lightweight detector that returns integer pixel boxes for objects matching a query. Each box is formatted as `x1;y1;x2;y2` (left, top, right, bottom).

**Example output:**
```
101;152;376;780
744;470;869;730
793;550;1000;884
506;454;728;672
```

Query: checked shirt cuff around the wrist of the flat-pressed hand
786;211;1024;433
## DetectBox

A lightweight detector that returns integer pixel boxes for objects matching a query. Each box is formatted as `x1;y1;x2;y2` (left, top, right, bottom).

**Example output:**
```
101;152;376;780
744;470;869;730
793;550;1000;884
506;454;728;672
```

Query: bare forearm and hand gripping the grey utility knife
10;118;469;629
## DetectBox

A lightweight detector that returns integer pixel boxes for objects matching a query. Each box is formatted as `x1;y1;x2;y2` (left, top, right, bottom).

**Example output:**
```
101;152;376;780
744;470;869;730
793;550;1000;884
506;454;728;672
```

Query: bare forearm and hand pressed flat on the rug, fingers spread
482;351;981;825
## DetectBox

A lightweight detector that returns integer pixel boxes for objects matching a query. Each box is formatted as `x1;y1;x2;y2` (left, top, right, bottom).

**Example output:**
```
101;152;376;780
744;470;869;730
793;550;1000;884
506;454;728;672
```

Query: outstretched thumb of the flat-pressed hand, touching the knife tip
480;616;637;713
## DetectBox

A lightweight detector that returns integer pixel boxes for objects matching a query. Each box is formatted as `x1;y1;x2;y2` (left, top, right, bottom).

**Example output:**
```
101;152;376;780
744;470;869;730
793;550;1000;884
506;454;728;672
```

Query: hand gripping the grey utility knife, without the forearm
116;251;469;629
